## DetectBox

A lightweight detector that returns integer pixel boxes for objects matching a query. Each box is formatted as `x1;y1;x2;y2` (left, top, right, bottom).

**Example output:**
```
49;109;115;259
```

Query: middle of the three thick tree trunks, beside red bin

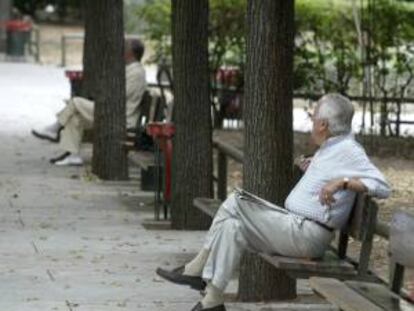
171;0;212;229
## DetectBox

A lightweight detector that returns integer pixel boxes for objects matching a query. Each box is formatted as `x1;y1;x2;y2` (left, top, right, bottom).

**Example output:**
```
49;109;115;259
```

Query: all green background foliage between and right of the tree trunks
137;0;414;98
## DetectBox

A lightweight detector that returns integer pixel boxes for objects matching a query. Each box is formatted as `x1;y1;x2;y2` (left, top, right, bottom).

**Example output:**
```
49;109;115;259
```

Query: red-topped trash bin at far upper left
6;20;32;56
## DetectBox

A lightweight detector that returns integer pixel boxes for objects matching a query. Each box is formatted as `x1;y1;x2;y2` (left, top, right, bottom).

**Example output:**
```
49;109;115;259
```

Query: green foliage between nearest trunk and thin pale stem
295;0;361;93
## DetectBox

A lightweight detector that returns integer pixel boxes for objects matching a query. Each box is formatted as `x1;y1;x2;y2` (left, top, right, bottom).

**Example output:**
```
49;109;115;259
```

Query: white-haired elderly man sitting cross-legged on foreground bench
157;94;390;311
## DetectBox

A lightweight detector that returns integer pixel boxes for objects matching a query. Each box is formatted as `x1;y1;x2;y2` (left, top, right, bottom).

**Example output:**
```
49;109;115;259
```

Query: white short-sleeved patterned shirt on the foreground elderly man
285;134;390;228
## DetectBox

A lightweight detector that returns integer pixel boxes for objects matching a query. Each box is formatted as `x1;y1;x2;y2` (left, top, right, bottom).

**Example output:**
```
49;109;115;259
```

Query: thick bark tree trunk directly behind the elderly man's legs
239;0;296;301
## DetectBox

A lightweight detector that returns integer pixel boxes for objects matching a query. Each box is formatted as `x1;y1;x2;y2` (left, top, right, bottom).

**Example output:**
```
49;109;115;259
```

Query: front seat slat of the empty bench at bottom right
309;277;384;311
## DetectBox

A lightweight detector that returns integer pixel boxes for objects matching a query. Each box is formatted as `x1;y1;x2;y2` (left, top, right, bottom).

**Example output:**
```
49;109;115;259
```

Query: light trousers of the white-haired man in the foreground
202;190;334;291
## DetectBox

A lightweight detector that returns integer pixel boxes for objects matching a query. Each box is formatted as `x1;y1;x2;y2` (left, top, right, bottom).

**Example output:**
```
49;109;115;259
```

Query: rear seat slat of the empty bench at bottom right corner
345;281;414;311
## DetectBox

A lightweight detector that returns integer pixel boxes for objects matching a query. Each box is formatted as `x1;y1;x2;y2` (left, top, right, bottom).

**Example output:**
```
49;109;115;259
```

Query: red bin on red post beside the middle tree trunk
146;122;175;203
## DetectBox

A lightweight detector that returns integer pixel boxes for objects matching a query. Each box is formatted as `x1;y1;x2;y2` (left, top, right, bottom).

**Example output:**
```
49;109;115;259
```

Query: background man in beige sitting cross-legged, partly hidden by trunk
32;39;147;165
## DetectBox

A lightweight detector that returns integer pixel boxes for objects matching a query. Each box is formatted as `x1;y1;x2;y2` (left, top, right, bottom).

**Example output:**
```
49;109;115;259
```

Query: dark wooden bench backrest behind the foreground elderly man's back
338;193;378;275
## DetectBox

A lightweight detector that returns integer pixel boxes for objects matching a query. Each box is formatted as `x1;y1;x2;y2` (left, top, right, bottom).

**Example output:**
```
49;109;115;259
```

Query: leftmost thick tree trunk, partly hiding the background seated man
84;0;128;180
